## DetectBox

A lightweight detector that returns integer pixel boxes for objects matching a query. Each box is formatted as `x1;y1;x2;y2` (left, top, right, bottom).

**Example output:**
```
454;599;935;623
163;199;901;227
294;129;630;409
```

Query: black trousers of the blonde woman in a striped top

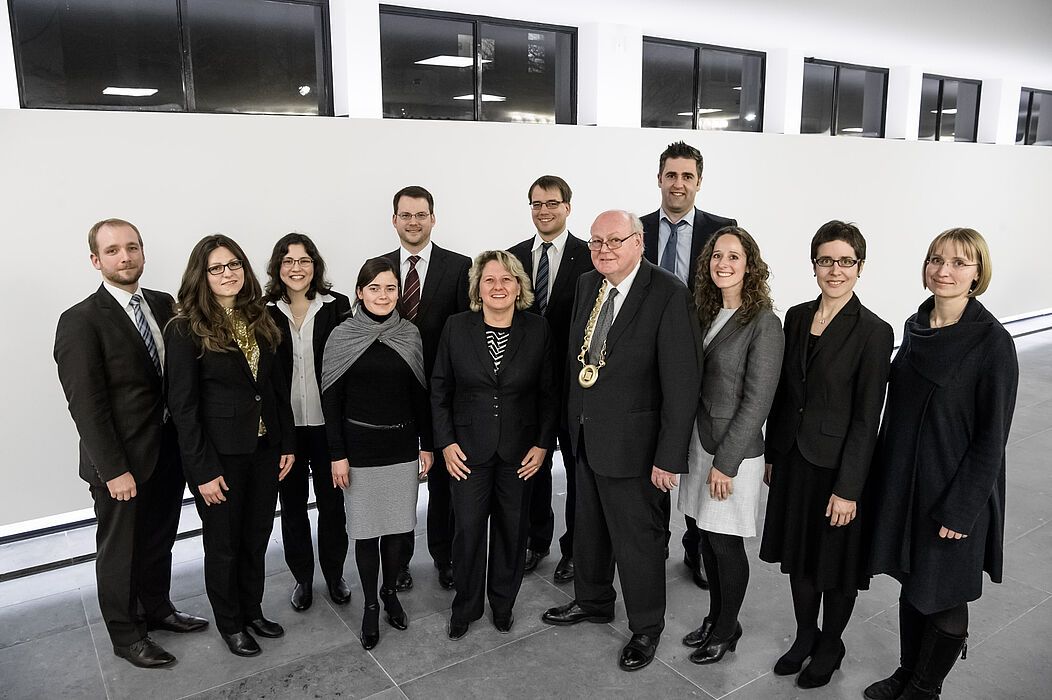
449;456;532;622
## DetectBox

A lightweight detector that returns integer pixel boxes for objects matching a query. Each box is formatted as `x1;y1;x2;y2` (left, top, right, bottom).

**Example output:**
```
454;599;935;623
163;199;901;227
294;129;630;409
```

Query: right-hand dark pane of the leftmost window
183;0;328;115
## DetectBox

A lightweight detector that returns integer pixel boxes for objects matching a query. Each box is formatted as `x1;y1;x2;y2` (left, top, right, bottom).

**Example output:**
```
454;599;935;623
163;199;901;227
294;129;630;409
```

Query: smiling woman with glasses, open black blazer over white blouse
266;234;350;611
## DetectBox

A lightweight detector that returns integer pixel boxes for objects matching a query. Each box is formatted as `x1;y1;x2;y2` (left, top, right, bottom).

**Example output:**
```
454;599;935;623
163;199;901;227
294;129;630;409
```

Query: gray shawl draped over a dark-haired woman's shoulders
322;309;427;392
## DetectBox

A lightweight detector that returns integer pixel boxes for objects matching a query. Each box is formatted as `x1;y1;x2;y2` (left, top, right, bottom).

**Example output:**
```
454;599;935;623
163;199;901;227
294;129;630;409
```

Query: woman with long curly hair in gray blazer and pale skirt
680;226;784;664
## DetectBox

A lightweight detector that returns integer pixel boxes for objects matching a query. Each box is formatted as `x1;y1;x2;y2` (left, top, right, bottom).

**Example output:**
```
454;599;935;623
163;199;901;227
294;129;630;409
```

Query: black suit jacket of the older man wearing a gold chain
566;260;701;477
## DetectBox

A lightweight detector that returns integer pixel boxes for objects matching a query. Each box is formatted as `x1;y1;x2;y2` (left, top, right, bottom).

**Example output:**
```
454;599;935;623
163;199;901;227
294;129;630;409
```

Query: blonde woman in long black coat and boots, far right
866;228;1019;699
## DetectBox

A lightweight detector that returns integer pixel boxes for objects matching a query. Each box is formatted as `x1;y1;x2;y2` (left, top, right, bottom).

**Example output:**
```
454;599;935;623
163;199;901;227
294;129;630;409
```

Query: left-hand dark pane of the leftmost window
11;0;186;109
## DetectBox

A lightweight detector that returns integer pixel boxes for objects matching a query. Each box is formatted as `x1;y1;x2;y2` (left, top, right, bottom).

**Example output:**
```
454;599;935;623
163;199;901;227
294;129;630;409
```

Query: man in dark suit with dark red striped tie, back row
384;185;471;591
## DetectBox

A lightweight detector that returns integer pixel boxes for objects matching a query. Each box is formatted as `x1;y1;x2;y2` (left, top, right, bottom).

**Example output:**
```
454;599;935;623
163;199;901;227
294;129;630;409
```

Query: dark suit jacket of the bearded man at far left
55;286;174;485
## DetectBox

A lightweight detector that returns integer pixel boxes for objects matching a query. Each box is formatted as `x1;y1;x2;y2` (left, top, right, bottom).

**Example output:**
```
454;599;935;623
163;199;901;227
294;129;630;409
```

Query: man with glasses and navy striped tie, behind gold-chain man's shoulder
508;175;594;583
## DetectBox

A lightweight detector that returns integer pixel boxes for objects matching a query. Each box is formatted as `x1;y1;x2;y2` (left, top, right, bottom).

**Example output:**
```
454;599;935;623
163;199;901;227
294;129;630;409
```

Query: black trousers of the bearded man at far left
90;423;186;646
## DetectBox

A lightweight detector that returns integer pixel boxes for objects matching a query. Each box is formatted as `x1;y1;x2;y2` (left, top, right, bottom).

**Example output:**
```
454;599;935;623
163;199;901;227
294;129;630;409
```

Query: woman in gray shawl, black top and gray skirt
322;258;432;649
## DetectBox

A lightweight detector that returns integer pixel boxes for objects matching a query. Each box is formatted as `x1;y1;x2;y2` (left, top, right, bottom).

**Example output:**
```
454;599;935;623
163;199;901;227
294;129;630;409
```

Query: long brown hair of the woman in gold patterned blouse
176;234;281;353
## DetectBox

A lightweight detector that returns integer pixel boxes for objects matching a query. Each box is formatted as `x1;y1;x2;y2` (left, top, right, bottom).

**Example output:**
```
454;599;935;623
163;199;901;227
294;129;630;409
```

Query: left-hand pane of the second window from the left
380;13;474;119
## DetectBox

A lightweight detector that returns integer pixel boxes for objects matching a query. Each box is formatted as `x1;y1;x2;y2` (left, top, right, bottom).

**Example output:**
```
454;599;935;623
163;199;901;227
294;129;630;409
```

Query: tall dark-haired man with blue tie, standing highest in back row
643;141;737;588
